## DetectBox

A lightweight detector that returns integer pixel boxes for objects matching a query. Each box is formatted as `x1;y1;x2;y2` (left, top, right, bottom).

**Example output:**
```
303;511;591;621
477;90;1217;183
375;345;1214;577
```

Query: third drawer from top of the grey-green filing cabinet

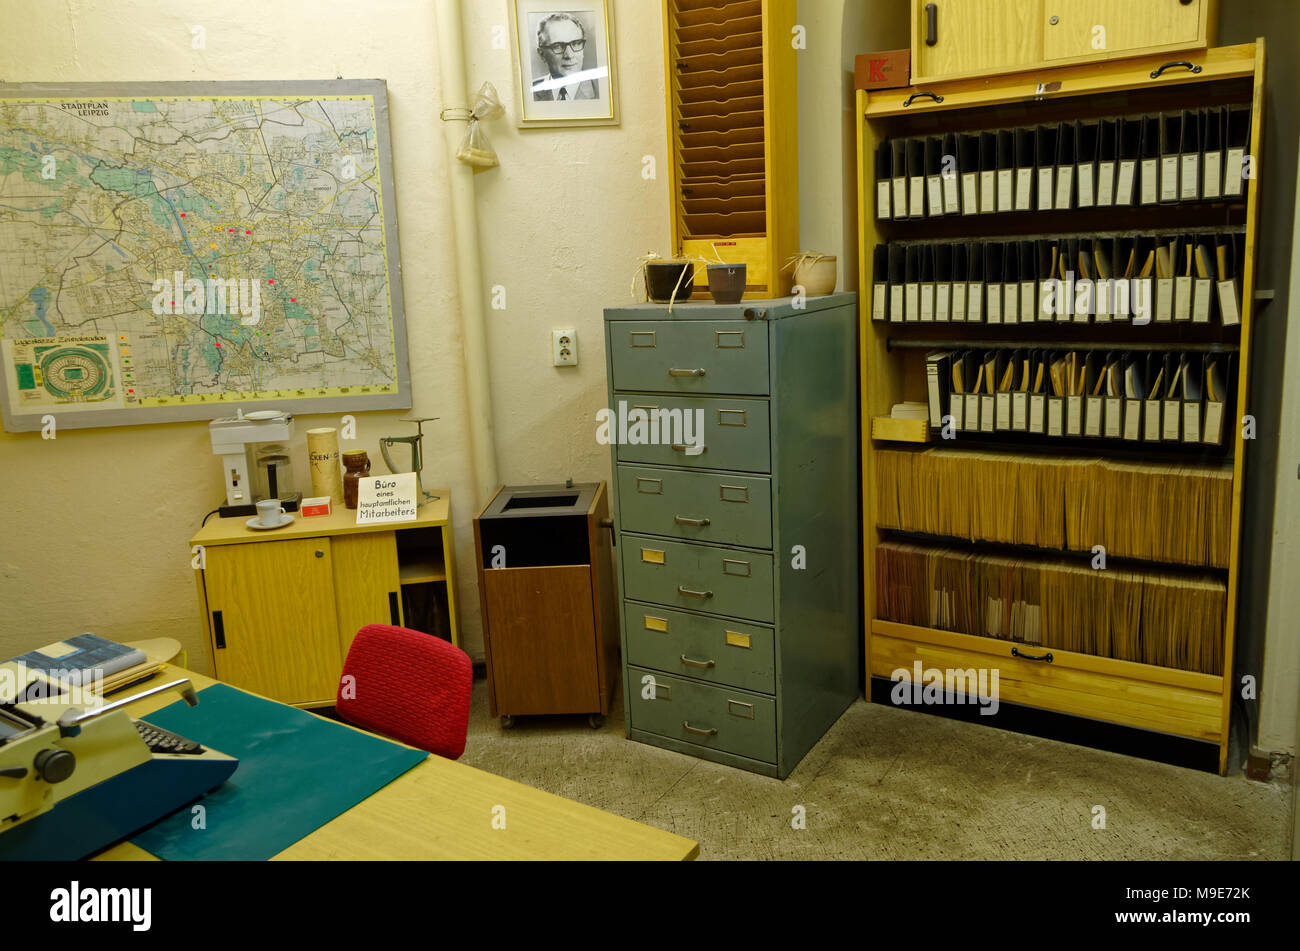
618;465;772;548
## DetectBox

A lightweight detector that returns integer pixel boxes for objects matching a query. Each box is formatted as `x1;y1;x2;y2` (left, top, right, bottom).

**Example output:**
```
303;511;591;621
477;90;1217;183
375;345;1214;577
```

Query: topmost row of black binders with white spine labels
876;105;1253;220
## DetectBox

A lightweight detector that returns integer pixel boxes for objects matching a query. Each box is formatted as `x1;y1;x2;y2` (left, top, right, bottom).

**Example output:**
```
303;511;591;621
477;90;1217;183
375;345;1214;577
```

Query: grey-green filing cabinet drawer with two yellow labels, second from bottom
623;602;776;694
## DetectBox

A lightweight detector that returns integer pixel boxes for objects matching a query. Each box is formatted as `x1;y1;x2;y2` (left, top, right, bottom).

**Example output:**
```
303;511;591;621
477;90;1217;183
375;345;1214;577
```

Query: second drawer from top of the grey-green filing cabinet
610;394;772;473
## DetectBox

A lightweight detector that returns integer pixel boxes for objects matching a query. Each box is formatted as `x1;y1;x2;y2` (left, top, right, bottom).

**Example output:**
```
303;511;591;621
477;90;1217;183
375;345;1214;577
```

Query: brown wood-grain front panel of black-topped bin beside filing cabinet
482;565;601;716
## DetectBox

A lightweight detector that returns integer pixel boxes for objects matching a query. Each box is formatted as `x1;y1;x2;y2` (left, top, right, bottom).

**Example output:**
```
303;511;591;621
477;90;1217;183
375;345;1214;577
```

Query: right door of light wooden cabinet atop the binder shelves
1043;0;1206;60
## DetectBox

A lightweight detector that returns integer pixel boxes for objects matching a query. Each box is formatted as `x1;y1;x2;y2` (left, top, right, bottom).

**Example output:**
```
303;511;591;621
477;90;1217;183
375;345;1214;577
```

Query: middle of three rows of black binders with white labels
871;231;1245;327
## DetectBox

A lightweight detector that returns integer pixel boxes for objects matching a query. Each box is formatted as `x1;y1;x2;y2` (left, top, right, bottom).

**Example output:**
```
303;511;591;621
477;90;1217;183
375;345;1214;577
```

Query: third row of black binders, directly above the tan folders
926;348;1236;446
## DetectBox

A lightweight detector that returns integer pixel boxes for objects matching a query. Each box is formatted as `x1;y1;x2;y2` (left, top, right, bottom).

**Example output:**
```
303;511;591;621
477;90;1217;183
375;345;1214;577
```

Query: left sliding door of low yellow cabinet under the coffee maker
204;538;342;704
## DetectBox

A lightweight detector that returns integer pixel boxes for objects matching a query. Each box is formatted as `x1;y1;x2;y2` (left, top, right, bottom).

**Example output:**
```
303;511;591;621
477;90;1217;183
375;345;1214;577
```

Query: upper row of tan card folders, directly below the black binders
872;448;1232;569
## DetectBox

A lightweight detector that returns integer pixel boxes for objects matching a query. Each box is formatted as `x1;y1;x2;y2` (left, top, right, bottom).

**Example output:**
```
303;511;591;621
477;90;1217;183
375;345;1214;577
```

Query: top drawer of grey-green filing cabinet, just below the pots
610;321;768;396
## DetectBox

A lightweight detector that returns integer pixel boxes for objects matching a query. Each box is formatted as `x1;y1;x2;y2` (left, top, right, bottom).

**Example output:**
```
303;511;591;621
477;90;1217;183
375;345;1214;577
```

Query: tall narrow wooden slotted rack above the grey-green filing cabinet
663;0;800;299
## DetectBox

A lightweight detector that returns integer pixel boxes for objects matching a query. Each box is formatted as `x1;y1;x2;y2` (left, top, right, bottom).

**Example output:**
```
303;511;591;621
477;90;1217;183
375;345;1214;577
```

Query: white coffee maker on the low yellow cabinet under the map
208;409;303;518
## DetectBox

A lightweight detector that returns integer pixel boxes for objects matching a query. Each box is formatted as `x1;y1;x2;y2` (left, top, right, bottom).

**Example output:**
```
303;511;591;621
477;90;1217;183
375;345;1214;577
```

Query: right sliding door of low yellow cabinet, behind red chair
330;531;403;660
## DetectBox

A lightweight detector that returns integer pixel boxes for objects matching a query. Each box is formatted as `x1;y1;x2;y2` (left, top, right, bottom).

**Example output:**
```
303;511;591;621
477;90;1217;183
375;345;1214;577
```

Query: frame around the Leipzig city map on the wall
0;79;412;433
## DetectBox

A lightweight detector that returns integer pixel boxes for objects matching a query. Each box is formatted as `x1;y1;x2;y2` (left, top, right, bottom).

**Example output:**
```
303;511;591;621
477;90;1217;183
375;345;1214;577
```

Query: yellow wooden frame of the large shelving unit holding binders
857;39;1265;773
